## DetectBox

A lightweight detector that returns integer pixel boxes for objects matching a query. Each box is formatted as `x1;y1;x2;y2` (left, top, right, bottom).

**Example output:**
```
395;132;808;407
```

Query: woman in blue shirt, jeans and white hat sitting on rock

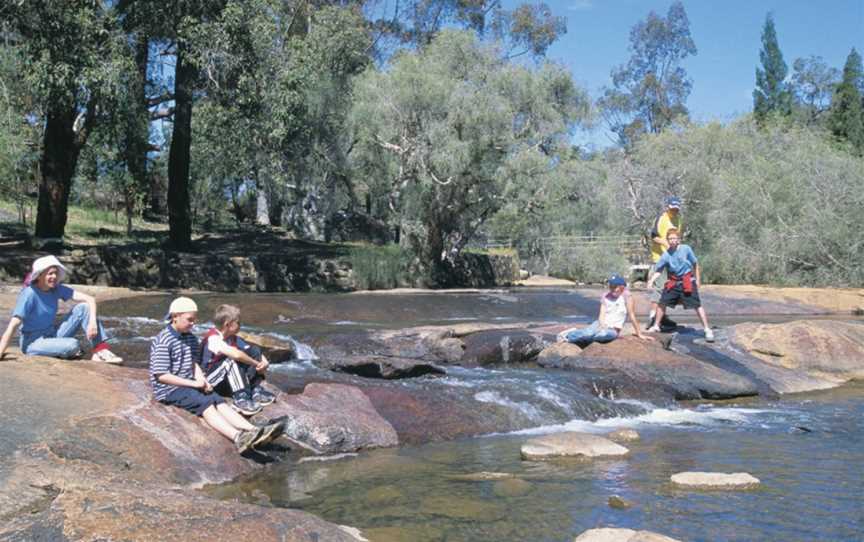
0;256;123;363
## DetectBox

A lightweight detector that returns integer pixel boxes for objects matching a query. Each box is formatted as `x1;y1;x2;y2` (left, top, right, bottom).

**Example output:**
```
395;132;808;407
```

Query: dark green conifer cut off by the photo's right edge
828;48;864;153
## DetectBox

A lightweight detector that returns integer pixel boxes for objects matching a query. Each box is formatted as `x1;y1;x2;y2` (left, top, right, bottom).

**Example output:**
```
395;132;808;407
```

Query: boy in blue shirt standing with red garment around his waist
648;228;714;342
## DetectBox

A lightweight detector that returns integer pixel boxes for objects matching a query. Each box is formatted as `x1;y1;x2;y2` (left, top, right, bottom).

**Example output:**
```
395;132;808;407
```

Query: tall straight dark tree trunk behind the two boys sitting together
168;43;196;250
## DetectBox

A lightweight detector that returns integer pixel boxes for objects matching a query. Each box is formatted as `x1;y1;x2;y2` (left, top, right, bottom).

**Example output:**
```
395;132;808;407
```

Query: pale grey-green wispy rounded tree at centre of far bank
353;30;589;285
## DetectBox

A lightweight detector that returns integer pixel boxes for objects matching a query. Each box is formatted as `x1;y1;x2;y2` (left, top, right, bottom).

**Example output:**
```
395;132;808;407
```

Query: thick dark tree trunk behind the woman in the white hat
36;105;81;238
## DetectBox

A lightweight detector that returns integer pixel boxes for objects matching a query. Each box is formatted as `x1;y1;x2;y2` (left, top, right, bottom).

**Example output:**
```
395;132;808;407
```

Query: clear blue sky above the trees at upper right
505;0;864;146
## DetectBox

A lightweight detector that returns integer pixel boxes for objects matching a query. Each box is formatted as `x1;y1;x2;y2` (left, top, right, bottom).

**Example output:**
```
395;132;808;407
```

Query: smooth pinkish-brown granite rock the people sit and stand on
0;286;864;540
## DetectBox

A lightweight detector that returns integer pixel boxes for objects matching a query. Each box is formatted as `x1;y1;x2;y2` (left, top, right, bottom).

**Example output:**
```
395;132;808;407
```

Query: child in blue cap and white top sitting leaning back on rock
558;274;654;348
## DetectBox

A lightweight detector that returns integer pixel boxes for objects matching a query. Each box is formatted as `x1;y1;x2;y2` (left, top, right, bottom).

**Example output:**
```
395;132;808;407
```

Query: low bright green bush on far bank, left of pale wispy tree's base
348;245;413;290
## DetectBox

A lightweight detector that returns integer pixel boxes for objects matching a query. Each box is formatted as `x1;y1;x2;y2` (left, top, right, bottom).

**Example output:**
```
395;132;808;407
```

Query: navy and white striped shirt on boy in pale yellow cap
150;325;200;401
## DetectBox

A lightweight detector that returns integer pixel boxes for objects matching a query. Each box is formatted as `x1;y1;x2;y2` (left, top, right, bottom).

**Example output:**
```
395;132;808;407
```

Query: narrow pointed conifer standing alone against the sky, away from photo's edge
753;13;792;121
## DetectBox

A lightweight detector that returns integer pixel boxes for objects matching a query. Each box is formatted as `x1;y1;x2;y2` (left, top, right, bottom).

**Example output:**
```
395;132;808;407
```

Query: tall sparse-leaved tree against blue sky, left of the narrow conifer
598;2;696;145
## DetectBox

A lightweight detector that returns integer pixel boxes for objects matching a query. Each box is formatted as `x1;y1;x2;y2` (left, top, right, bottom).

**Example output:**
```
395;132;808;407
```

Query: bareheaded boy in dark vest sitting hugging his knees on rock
201;305;276;416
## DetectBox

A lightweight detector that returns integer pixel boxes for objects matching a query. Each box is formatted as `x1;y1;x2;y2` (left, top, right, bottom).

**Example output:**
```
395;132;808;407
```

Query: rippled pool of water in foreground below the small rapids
208;384;864;542
